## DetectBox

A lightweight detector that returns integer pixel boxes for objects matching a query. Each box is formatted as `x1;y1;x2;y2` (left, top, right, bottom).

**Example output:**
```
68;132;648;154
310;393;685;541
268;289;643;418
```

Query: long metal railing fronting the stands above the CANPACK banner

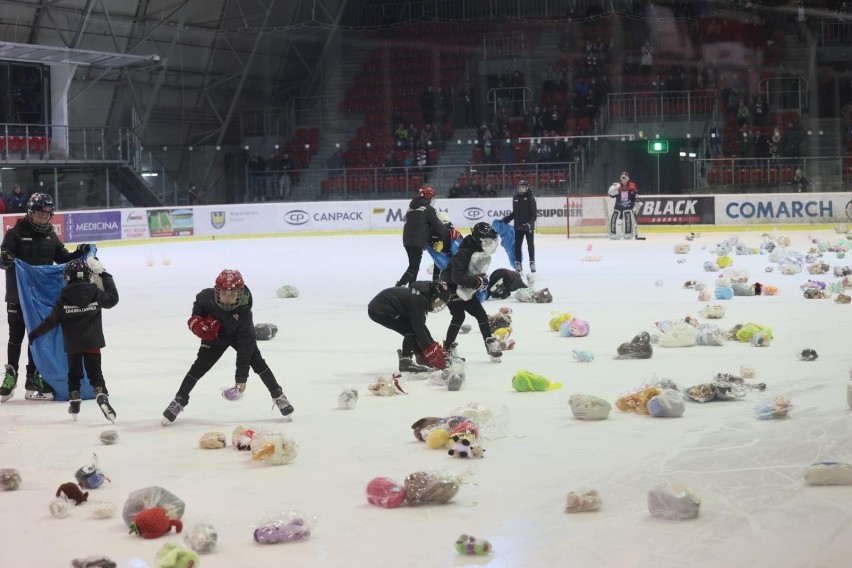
240;162;581;202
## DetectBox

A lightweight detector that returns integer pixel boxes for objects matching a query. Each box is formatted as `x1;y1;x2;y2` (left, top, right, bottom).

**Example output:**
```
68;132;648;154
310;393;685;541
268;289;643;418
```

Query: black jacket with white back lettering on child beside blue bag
30;272;118;353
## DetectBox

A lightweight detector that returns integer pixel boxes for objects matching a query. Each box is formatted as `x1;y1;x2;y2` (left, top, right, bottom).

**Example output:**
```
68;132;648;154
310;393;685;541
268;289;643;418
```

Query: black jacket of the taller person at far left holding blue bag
0;217;86;304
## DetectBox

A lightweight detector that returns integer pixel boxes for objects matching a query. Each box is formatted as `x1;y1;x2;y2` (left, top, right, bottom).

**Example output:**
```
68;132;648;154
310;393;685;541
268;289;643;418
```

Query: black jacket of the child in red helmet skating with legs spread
192;286;257;383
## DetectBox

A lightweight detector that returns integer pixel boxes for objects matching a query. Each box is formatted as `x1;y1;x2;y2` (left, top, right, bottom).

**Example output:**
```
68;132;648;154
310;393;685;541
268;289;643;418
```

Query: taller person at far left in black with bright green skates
0;193;90;402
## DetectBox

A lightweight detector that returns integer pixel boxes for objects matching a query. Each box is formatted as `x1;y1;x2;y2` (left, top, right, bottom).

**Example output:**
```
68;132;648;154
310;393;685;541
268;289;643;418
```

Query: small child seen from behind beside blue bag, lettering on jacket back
29;259;118;422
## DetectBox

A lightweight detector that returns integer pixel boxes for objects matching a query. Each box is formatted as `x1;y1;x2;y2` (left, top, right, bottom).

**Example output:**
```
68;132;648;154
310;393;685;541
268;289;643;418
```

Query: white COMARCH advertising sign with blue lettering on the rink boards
716;193;850;225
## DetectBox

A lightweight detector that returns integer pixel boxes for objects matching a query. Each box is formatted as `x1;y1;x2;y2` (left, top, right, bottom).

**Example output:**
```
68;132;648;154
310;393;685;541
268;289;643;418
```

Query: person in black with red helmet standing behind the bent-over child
396;185;450;286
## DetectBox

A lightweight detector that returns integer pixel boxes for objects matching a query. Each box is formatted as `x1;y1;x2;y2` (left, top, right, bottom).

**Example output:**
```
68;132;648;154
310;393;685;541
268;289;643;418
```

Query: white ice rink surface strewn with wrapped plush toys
0;230;852;568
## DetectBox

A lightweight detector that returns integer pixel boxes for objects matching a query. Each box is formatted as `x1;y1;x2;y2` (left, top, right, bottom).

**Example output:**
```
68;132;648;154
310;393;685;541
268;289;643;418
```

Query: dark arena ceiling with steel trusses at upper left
0;0;357;145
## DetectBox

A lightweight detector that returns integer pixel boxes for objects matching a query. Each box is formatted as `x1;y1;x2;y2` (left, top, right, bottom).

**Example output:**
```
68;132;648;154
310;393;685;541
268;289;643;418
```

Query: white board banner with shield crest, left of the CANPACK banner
193;204;284;236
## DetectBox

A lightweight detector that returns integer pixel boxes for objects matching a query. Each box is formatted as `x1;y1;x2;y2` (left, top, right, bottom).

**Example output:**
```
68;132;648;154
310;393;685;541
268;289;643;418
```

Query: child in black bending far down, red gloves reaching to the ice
367;281;450;373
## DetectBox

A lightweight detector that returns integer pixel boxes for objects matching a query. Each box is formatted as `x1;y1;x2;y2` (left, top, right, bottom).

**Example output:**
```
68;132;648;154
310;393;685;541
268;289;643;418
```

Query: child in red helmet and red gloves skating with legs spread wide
162;270;293;426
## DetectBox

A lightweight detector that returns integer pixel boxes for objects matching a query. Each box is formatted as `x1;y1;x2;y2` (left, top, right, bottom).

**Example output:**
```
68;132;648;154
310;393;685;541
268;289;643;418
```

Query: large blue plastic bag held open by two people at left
15;250;95;400
